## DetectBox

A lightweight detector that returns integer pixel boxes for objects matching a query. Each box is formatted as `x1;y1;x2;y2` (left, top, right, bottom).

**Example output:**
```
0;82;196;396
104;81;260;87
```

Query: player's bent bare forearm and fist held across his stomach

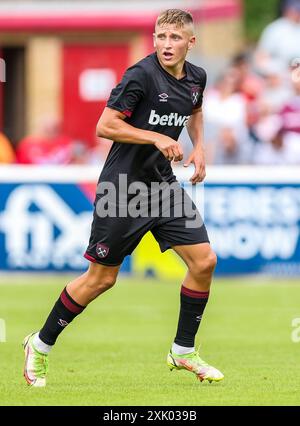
96;107;183;161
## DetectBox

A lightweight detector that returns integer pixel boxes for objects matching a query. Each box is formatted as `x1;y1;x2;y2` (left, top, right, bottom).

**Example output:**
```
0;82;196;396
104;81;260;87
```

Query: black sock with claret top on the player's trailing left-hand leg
39;288;85;345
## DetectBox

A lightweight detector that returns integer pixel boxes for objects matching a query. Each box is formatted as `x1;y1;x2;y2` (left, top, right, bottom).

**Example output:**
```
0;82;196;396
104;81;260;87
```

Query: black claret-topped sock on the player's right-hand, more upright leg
174;286;209;348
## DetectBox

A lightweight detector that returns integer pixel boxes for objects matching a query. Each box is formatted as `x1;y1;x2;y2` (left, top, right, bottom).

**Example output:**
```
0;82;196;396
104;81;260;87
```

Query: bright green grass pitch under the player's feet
0;275;300;406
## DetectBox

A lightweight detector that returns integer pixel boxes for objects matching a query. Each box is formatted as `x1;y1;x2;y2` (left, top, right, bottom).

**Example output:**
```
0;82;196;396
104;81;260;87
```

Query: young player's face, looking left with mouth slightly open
154;24;195;68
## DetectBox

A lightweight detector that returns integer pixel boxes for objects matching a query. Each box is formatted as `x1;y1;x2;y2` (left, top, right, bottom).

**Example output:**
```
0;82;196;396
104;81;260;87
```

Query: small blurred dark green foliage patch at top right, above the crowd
244;0;279;42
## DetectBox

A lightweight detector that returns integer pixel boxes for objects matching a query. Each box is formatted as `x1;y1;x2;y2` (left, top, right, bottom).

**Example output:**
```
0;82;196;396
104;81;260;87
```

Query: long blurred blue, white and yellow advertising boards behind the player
0;166;300;279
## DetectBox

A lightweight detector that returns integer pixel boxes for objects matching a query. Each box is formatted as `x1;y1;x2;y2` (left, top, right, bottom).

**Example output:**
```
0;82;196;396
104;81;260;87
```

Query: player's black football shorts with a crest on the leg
84;185;209;266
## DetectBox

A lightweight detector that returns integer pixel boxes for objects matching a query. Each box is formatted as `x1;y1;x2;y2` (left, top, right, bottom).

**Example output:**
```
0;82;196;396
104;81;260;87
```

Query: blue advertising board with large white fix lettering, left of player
0;182;131;272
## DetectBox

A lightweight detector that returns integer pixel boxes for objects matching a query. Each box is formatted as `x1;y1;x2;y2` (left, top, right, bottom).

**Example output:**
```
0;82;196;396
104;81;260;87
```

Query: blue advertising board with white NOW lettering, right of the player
204;184;300;275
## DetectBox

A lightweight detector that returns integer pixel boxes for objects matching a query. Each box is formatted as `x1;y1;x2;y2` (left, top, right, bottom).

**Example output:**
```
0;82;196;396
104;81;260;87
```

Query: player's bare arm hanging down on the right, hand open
184;108;206;184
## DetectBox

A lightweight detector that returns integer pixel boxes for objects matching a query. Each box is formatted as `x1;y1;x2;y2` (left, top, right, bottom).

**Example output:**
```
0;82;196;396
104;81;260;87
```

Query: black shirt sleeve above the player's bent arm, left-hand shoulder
107;65;147;117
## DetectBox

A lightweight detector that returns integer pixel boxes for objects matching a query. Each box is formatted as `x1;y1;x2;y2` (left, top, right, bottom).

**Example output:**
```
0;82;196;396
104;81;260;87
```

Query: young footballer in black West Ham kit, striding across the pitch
23;9;224;386
